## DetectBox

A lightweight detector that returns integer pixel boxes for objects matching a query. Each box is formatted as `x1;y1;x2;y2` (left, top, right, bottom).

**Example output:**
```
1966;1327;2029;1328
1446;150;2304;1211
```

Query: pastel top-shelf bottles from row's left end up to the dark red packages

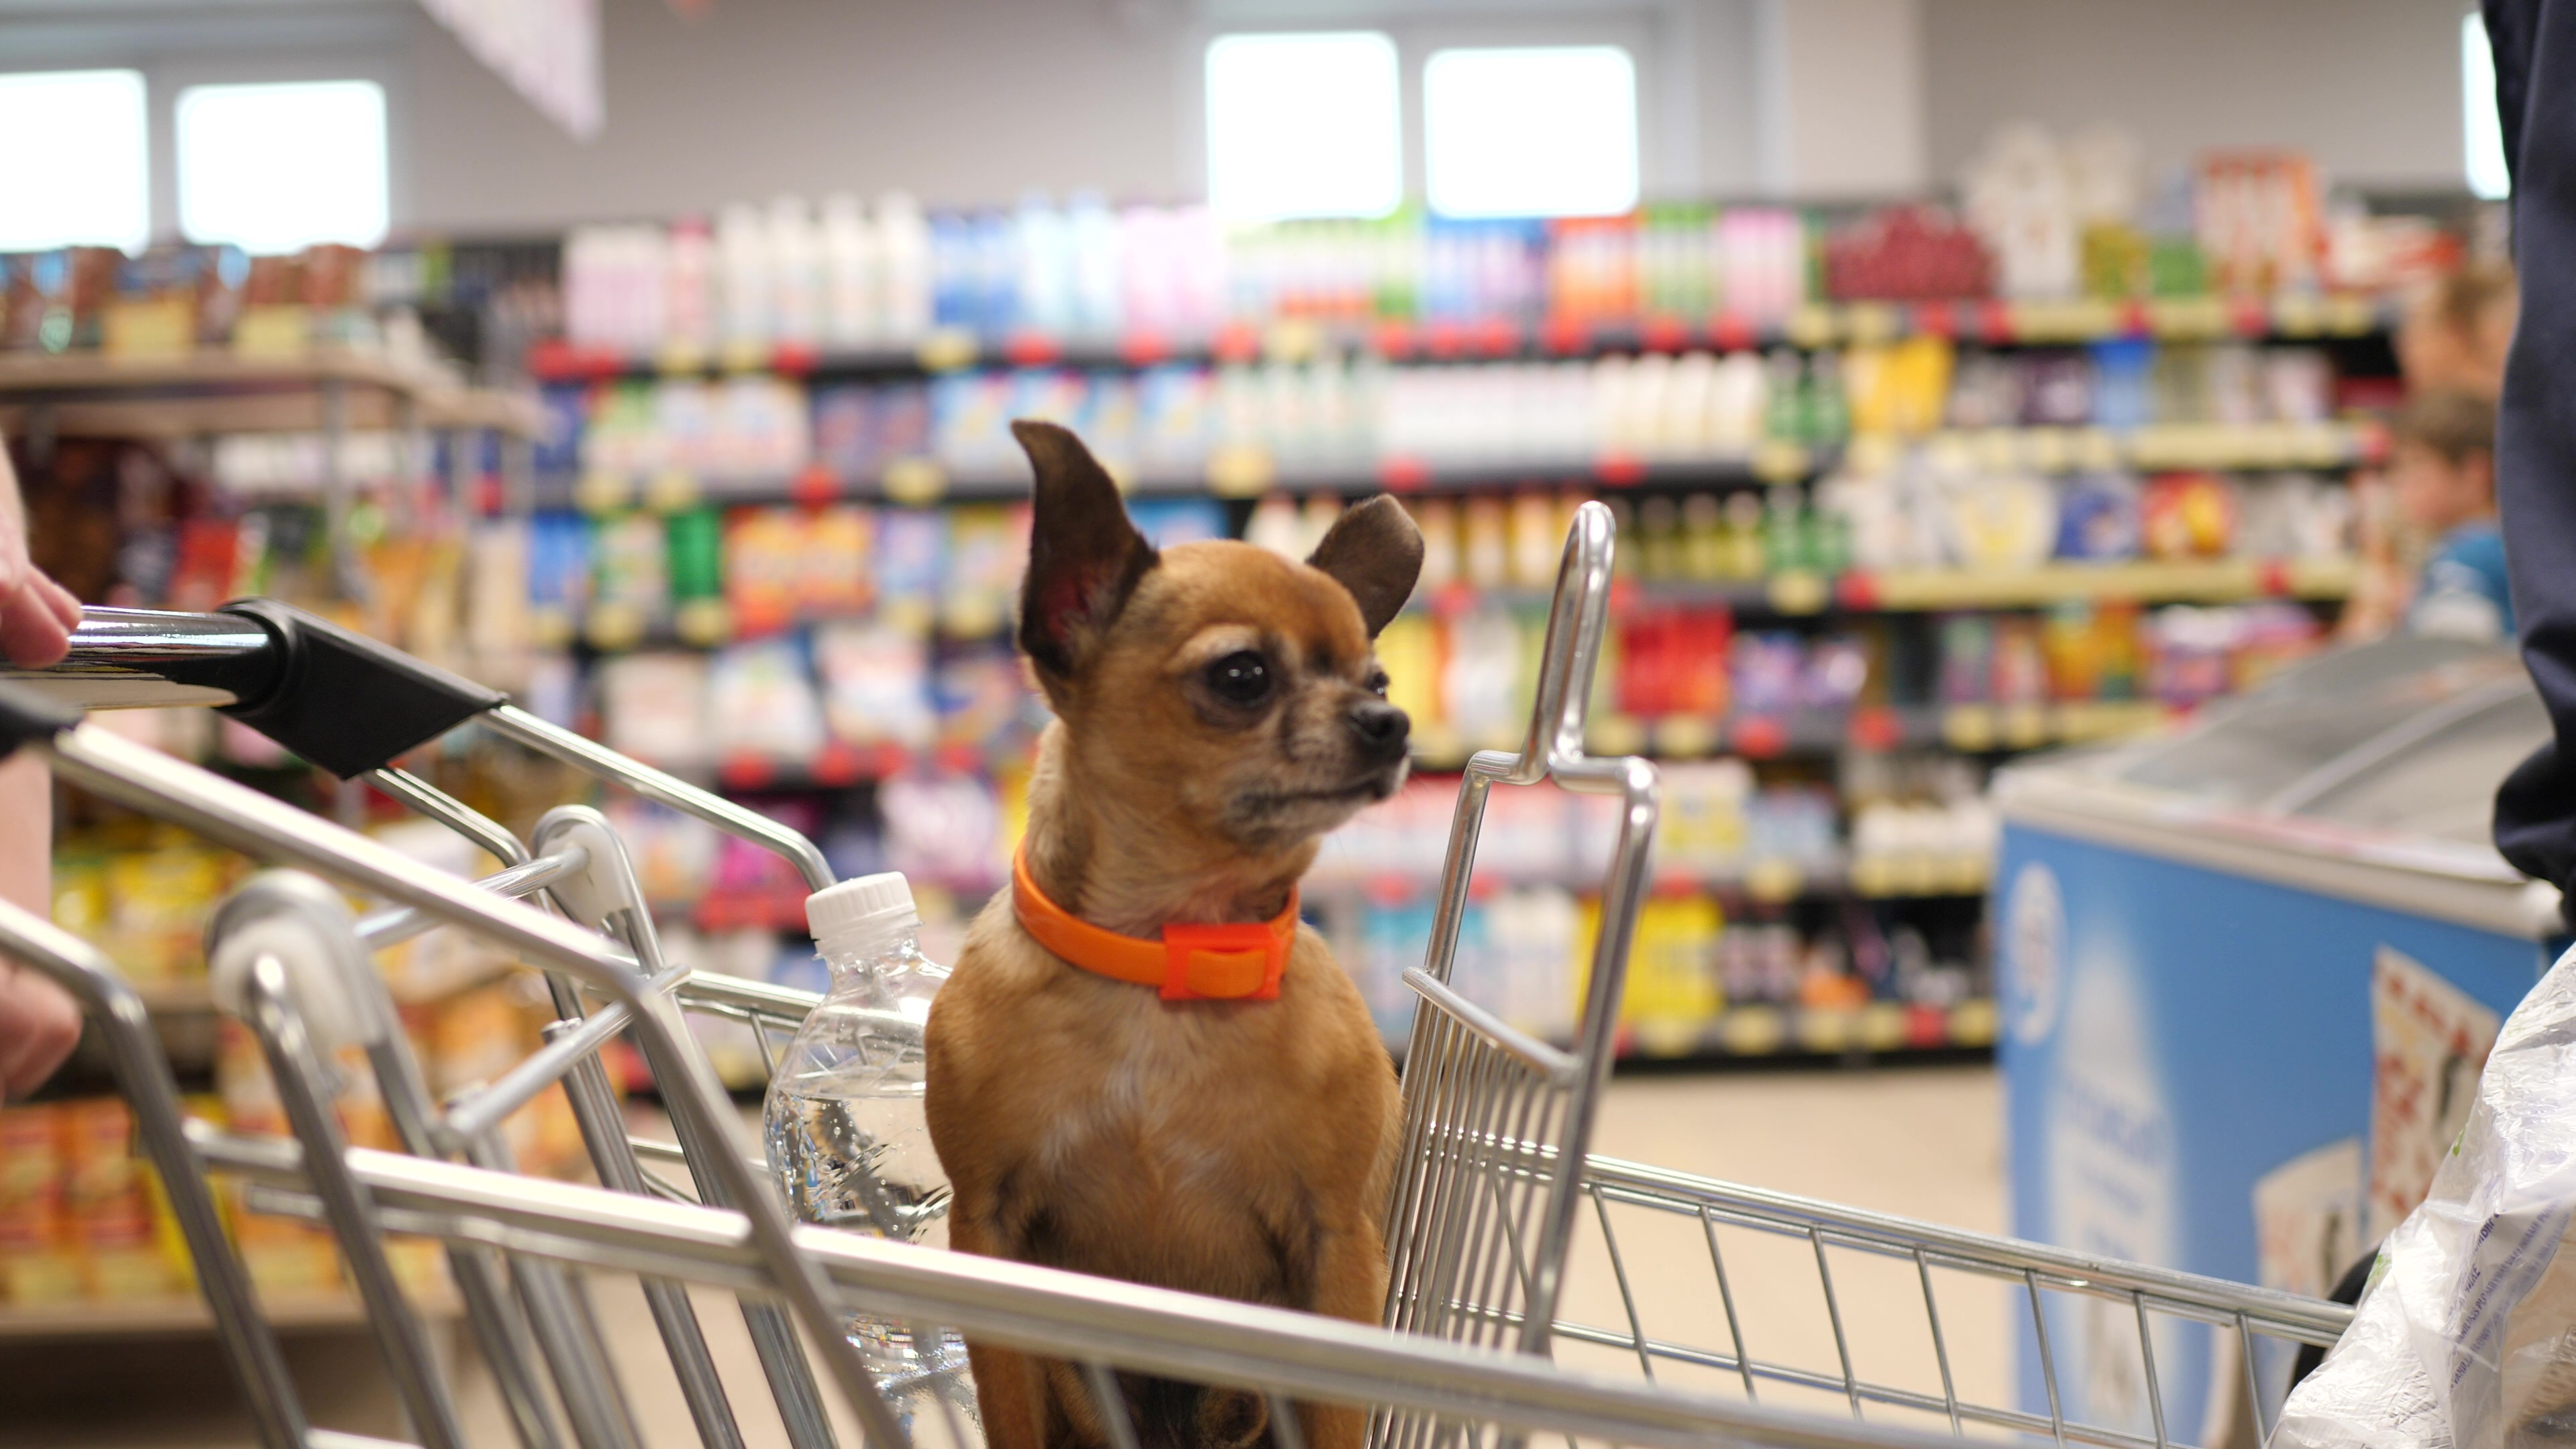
561;193;1809;354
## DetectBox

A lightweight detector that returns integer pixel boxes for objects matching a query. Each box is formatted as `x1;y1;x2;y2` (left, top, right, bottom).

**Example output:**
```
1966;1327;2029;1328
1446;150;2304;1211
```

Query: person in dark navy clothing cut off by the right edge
2486;0;2576;910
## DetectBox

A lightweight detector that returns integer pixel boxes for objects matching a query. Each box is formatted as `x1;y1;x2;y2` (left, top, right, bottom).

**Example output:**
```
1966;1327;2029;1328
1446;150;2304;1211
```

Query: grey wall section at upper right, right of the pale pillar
1927;0;2471;189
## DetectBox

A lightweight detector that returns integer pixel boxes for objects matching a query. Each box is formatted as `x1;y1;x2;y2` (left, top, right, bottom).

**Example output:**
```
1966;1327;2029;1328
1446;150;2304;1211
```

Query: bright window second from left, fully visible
178;80;389;253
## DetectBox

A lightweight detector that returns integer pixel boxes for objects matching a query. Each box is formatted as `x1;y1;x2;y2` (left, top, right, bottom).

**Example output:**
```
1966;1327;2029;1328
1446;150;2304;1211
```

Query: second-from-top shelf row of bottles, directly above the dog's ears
539;337;2337;485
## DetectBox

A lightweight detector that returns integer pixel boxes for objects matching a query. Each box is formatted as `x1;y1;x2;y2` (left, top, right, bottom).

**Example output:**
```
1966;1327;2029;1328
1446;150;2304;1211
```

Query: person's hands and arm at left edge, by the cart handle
0;446;80;1101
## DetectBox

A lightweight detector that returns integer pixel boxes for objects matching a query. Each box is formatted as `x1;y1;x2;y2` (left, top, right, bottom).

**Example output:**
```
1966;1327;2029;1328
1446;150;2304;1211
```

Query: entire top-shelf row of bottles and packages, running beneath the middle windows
561;154;2457;354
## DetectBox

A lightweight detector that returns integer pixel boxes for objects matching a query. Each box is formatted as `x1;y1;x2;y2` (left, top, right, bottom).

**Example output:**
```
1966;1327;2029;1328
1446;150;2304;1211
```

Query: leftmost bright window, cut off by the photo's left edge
0;70;152;253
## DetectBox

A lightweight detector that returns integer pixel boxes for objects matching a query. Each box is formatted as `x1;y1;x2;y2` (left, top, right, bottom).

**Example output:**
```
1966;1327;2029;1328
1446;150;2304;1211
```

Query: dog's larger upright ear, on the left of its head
1010;420;1157;678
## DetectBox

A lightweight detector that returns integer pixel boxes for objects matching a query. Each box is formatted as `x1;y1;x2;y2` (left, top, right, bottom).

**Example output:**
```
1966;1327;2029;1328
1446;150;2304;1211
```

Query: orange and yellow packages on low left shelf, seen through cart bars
0;974;588;1312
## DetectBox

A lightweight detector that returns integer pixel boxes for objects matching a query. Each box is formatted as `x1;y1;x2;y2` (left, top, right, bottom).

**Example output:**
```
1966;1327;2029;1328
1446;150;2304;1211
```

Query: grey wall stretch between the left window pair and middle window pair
405;0;1183;229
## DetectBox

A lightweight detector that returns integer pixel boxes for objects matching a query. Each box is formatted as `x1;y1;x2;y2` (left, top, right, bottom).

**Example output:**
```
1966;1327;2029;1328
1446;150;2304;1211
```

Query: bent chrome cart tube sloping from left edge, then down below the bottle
36;727;904;1446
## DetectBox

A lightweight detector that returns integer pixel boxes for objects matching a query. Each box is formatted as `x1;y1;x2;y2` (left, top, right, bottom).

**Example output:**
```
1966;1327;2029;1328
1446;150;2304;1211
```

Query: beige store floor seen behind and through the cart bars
0;1067;2009;1449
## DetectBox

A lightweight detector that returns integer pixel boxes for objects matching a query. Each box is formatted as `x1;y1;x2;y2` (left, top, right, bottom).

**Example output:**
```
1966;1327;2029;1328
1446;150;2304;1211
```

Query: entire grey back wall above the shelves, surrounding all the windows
0;0;2465;235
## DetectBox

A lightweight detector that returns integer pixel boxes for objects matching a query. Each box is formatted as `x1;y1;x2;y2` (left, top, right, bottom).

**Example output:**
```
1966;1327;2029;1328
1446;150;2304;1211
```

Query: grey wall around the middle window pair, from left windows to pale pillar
396;0;1772;229
